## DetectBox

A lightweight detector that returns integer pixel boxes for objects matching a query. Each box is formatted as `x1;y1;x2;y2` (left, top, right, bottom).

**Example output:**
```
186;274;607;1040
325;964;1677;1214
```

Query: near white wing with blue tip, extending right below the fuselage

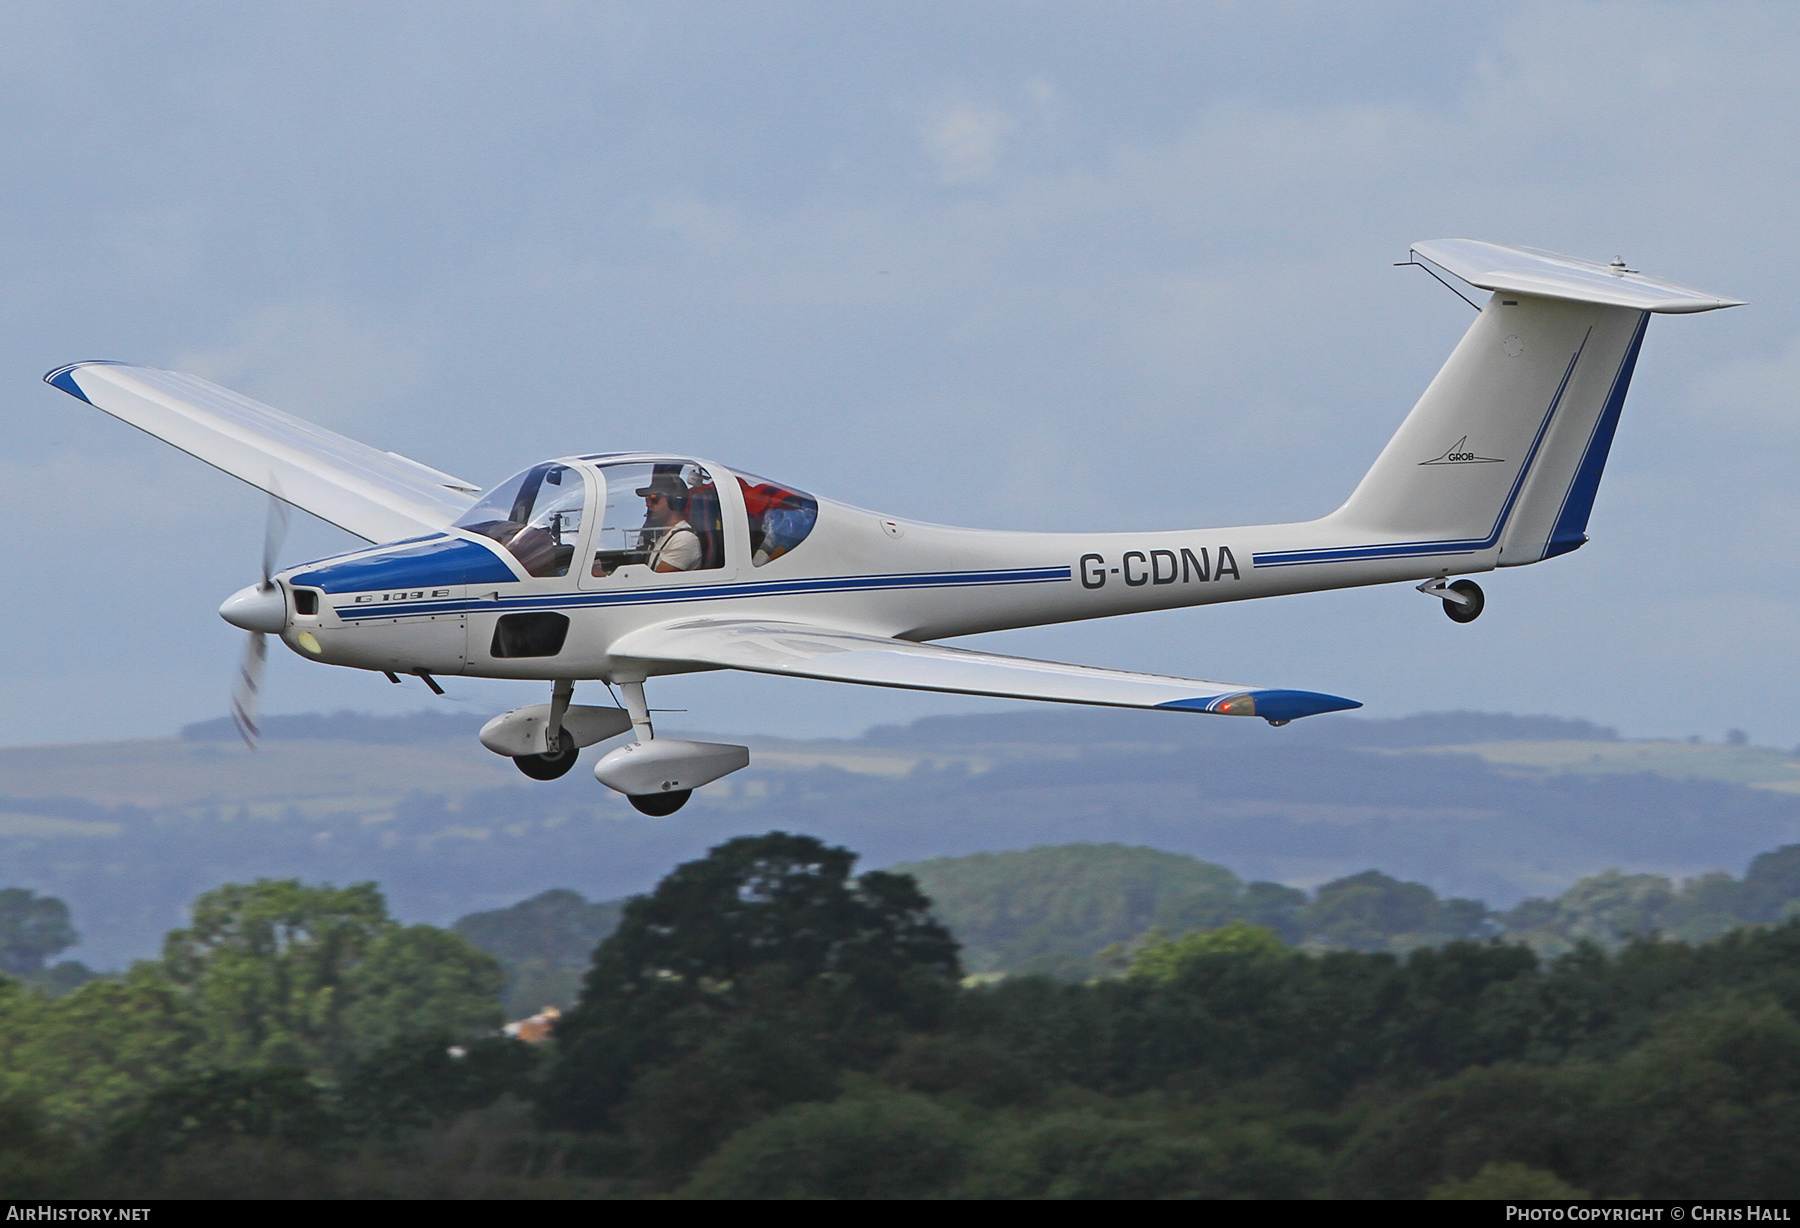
612;619;1363;724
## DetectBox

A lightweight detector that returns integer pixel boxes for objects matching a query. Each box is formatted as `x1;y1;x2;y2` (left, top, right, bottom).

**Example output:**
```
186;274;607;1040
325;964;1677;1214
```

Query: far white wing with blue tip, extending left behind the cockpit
43;362;479;542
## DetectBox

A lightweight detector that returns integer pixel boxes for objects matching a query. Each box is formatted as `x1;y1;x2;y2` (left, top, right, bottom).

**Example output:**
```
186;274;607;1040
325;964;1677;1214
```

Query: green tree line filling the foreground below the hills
0;832;1800;1197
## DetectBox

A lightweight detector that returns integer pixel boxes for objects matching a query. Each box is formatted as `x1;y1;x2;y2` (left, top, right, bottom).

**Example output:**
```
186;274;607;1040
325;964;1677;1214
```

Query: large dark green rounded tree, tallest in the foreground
544;832;961;1129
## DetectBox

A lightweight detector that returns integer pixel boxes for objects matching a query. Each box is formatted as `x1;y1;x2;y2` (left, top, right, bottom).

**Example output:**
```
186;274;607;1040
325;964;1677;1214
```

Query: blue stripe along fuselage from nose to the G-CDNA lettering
337;567;1075;621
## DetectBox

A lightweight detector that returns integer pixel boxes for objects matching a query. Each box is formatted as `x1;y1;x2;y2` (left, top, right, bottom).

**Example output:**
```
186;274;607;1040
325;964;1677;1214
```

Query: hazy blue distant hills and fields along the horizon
0;709;1800;967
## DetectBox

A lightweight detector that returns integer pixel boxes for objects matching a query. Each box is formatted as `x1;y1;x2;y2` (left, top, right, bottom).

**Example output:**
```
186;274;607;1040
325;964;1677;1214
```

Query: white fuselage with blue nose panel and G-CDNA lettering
277;454;1499;681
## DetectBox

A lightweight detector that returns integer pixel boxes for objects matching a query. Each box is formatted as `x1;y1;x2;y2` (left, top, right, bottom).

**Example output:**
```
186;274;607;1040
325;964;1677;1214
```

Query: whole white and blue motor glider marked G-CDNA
45;239;1735;814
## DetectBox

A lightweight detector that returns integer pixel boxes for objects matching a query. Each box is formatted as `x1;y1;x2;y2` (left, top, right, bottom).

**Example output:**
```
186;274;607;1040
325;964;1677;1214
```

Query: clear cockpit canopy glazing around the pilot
457;457;819;583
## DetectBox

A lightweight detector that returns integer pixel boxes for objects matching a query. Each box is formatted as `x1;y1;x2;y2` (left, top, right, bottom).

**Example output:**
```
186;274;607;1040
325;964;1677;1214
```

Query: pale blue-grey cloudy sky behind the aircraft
0;0;1800;745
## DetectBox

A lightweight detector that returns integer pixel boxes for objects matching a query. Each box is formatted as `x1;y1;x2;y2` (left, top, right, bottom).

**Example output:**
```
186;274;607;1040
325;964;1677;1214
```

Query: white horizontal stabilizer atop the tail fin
1413;239;1742;313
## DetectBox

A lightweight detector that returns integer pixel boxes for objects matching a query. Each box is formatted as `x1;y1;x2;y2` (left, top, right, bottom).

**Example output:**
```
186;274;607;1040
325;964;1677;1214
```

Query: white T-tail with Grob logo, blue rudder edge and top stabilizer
1332;239;1737;569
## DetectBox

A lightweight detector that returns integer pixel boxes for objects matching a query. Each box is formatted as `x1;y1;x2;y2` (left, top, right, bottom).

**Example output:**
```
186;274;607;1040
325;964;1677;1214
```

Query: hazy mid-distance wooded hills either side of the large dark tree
455;843;1800;986
